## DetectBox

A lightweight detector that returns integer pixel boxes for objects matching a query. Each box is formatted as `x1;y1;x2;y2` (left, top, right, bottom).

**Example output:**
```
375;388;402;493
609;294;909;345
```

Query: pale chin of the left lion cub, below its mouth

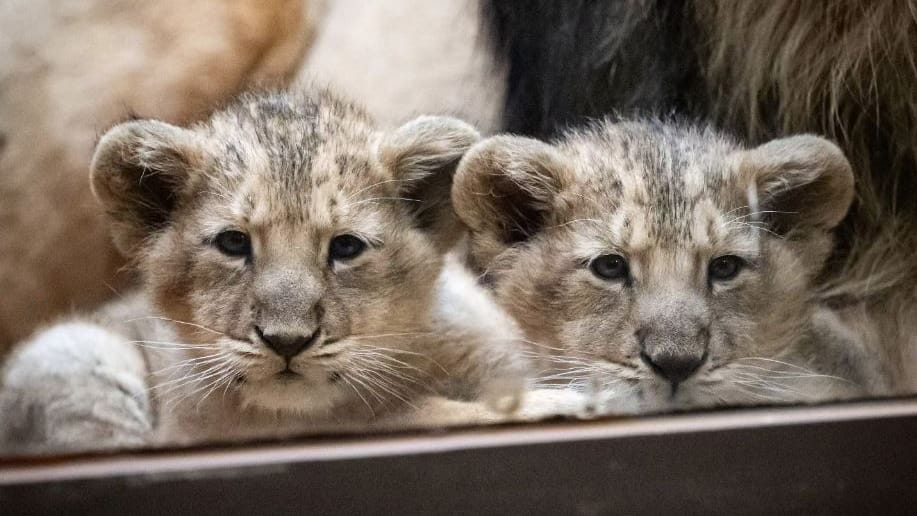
239;373;347;416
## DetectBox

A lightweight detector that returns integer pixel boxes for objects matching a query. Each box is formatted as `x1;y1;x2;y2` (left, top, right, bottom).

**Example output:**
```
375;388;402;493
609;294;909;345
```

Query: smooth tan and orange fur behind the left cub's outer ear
0;0;315;355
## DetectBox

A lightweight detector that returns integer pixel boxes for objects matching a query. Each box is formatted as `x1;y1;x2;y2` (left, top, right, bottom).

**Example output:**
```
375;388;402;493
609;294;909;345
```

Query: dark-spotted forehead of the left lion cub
198;93;388;225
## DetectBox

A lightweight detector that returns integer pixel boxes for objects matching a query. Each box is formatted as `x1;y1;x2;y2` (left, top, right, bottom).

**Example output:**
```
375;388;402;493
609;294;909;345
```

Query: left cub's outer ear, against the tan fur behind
90;120;203;254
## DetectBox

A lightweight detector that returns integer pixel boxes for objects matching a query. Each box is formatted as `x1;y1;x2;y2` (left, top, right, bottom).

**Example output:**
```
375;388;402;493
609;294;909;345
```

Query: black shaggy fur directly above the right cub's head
482;0;706;138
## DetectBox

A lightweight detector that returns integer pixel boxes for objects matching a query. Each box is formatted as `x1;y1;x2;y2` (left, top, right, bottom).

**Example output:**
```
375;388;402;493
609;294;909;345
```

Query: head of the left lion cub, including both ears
92;92;478;412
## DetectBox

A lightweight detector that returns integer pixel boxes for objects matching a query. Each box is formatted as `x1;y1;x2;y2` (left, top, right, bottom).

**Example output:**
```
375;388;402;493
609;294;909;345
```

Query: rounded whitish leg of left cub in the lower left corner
0;322;153;453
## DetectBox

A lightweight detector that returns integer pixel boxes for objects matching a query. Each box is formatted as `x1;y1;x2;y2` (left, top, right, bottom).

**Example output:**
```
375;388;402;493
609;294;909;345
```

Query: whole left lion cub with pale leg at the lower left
0;92;525;451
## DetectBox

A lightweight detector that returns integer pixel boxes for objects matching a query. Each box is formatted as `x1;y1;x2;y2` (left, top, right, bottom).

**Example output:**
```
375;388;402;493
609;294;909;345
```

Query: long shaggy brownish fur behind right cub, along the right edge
695;0;917;400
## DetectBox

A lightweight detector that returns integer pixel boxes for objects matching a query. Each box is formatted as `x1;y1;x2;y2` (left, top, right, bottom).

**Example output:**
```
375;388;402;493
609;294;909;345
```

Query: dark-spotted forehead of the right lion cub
561;122;742;248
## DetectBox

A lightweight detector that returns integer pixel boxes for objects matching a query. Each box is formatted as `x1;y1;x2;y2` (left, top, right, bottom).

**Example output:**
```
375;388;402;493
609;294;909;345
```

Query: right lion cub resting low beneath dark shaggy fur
453;121;869;412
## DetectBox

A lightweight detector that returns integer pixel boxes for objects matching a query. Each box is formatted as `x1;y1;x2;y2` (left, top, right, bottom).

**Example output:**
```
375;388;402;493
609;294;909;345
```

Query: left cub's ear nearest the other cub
379;116;481;251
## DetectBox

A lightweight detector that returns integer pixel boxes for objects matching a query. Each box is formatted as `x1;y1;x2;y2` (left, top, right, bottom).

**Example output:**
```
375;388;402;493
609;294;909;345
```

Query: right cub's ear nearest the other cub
452;136;574;269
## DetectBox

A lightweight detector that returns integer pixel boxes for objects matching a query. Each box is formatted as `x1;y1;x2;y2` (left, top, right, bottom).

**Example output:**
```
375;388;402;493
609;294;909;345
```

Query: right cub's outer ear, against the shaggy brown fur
740;135;854;234
